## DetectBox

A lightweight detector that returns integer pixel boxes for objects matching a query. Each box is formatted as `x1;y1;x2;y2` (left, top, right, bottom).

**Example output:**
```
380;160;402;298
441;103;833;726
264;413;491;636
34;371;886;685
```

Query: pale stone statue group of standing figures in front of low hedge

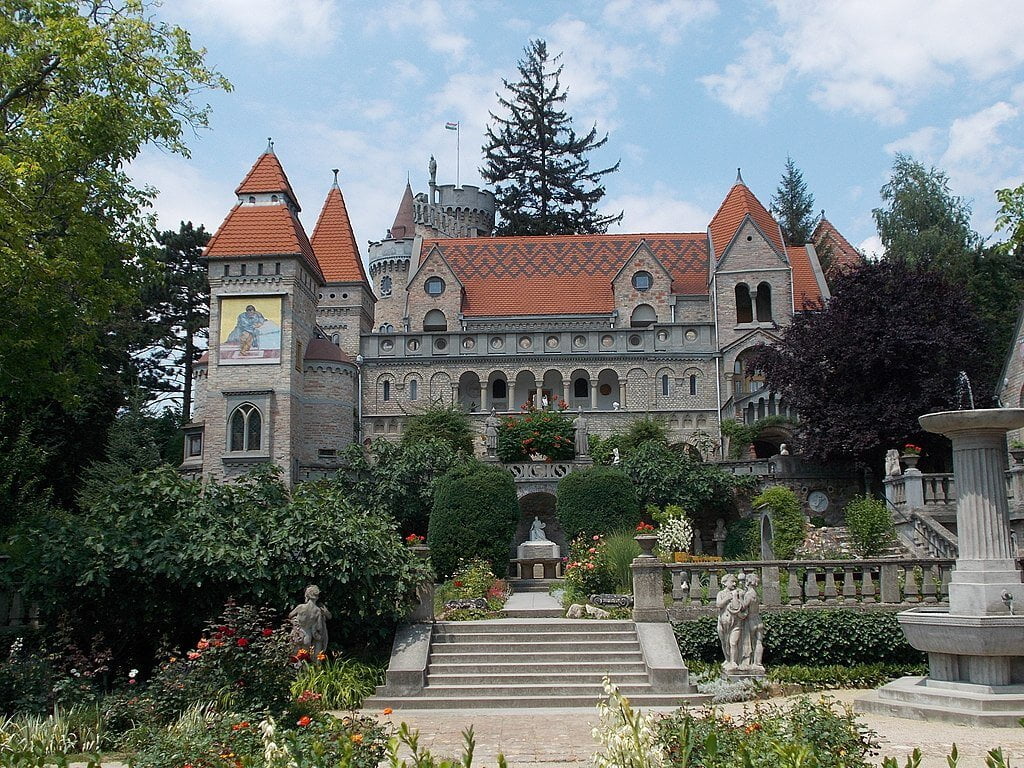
715;573;765;675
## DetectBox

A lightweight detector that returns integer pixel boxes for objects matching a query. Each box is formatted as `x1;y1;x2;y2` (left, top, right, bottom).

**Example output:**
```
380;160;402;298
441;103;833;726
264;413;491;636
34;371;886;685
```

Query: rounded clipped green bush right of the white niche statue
556;466;641;539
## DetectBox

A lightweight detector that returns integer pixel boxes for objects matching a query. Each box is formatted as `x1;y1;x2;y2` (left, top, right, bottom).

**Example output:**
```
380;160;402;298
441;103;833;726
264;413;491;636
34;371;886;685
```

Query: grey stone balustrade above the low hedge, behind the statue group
666;558;955;613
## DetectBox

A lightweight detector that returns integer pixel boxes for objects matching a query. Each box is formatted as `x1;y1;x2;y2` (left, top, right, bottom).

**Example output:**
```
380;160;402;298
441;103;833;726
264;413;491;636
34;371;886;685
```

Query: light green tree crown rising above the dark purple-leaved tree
871;154;981;279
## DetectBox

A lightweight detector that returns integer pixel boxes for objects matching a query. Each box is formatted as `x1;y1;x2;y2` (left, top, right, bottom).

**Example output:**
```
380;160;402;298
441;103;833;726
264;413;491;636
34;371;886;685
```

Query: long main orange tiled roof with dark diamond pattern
422;232;708;316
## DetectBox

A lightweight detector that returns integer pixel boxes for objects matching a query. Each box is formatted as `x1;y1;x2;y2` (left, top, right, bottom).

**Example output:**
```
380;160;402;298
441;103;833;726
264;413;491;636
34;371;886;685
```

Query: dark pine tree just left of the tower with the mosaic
143;221;210;421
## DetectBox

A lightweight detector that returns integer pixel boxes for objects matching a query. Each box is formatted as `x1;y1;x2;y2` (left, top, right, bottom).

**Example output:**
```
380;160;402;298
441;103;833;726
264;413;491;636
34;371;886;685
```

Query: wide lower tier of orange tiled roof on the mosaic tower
204;203;324;281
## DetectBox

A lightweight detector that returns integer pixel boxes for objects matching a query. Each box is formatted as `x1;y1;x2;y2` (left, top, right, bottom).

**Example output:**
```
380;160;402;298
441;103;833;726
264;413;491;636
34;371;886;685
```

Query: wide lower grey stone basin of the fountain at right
897;607;1024;656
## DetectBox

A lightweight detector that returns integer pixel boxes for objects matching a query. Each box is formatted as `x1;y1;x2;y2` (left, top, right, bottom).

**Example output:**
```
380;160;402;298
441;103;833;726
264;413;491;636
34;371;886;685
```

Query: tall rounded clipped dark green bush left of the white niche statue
427;461;519;577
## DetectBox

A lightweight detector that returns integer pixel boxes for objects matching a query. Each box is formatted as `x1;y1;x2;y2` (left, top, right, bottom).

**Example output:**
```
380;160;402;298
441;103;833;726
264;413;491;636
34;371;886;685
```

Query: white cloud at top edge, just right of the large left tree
173;0;339;52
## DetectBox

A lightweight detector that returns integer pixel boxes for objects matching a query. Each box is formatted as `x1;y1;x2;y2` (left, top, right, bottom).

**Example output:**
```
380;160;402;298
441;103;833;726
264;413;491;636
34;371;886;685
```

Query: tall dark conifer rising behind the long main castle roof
480;40;623;234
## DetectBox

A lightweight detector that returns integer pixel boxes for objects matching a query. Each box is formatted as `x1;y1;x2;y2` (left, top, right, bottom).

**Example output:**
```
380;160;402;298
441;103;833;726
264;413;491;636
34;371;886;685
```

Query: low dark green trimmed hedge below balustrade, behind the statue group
674;610;926;667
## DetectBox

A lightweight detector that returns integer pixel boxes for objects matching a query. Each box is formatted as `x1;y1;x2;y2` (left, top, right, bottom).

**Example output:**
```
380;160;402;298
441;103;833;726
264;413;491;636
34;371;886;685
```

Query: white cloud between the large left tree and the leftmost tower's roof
128;147;227;234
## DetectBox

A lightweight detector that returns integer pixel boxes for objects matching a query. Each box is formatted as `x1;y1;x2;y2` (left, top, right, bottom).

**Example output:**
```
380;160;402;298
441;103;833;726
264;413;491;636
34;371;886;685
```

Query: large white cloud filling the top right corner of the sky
703;0;1024;124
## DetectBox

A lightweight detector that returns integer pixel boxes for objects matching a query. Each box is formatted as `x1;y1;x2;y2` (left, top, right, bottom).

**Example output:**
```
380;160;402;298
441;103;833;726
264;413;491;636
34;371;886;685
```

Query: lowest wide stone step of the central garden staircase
362;690;711;711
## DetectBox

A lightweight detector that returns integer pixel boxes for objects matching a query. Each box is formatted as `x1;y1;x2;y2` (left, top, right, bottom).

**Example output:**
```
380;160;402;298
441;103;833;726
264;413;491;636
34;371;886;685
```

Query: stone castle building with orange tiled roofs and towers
182;146;858;481
